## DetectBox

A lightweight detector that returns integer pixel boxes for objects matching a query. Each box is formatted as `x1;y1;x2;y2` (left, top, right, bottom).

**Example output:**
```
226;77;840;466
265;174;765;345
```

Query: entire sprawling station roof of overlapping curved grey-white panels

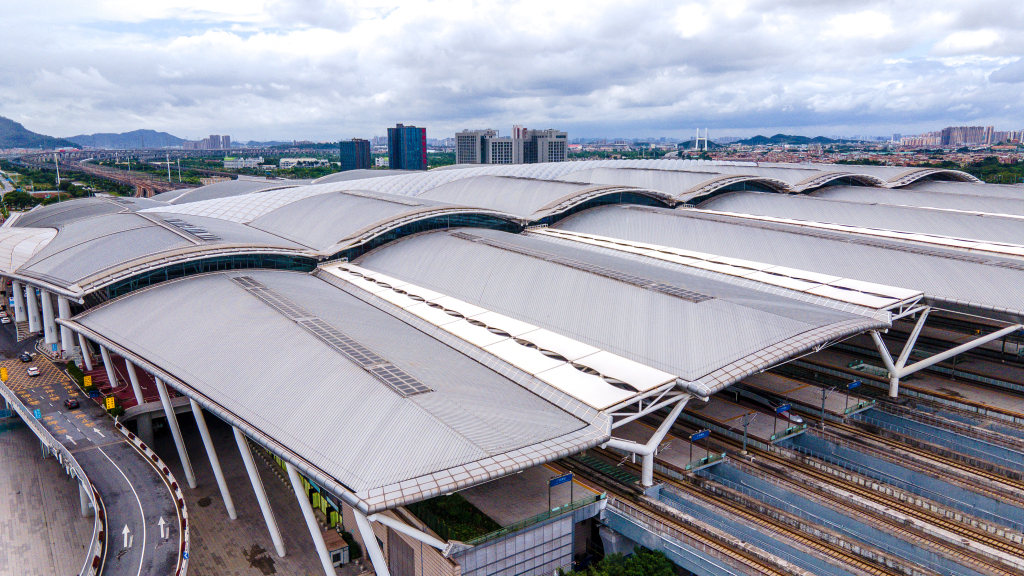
0;160;1007;511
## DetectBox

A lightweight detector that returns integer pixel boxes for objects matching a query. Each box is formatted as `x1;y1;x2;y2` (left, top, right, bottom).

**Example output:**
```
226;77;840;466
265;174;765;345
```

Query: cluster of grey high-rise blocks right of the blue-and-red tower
456;125;568;164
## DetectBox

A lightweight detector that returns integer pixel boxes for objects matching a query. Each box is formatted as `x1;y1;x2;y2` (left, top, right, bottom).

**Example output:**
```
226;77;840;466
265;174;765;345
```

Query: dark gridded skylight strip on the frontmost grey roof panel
231;276;433;398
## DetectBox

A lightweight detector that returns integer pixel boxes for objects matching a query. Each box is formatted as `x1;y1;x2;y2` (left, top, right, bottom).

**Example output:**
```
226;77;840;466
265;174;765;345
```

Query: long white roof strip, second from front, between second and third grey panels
531;229;922;310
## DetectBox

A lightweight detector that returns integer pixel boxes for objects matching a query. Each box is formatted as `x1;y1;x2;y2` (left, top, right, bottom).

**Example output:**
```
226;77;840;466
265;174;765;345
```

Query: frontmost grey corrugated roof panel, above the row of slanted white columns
78;271;586;492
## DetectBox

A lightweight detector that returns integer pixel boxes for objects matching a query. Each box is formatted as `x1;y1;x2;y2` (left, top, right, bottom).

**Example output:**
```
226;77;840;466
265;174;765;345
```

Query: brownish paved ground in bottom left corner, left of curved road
0;416;93;576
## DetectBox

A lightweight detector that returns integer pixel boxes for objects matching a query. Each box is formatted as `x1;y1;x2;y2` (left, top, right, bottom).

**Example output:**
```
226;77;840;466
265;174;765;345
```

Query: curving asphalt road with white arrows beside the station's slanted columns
0;317;181;576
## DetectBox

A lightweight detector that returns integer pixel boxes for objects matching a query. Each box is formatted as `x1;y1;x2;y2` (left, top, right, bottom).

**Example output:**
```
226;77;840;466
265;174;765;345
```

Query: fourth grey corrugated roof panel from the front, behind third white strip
700;192;1024;245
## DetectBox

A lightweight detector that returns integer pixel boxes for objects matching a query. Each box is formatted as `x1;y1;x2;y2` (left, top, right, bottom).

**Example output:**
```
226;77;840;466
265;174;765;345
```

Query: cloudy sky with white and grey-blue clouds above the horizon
0;0;1024;140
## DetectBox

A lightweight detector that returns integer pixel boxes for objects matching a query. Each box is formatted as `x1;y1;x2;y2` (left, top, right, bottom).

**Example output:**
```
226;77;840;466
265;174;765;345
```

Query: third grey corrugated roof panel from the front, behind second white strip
556;201;1024;316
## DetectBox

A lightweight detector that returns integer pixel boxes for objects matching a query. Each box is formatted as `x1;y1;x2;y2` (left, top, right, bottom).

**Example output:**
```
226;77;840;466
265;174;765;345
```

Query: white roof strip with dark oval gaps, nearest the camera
321;263;676;410
